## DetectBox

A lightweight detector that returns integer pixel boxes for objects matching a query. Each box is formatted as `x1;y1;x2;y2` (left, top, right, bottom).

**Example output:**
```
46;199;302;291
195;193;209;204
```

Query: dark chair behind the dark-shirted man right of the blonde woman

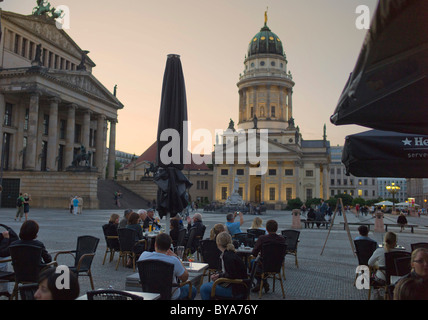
254;243;287;299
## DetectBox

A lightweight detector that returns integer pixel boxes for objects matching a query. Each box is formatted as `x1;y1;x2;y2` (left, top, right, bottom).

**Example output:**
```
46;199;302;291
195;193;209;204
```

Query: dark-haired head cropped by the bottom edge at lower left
34;268;80;300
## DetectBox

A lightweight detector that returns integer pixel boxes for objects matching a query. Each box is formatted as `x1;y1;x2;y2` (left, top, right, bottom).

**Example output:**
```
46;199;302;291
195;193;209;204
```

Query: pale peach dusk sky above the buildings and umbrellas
0;0;377;155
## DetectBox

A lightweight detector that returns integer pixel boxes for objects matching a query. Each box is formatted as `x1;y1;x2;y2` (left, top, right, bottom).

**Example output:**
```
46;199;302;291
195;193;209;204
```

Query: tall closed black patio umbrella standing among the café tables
154;54;192;221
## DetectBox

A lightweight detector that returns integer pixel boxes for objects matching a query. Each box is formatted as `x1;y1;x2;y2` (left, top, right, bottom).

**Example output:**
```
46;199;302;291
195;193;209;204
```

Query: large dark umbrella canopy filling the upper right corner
330;0;428;134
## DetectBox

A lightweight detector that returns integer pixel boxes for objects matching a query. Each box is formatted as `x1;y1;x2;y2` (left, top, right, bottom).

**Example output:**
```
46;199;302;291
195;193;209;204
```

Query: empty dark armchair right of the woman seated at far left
54;236;100;290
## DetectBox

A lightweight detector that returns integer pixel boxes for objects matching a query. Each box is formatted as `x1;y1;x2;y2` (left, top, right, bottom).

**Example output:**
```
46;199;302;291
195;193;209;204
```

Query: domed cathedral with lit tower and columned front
213;18;330;209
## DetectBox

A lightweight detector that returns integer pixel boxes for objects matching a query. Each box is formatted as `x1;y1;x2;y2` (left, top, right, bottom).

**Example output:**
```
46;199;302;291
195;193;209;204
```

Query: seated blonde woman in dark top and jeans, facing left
200;232;248;300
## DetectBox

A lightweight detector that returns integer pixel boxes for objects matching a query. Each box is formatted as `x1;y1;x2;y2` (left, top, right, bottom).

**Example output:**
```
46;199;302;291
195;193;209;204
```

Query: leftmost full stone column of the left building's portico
25;92;40;170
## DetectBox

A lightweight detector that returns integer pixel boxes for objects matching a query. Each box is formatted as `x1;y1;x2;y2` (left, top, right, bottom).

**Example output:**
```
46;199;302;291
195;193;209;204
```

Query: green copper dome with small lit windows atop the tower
248;23;284;57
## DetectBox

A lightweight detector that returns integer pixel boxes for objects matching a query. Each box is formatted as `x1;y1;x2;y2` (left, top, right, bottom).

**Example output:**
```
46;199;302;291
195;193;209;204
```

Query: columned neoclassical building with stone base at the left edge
0;11;123;208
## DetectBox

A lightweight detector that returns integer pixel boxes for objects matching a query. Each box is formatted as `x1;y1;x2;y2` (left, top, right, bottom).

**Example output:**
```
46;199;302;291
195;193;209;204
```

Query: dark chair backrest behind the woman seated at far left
9;244;43;282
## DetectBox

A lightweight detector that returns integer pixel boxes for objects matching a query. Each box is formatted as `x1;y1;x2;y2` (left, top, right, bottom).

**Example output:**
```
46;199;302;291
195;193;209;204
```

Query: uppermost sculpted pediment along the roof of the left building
1;11;95;67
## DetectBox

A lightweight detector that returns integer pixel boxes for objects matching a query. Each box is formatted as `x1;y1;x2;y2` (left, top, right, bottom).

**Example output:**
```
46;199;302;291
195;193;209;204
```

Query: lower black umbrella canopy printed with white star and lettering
342;130;428;178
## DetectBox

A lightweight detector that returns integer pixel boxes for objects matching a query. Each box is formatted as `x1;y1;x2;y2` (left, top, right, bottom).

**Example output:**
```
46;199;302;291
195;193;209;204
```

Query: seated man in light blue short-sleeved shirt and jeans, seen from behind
138;233;196;300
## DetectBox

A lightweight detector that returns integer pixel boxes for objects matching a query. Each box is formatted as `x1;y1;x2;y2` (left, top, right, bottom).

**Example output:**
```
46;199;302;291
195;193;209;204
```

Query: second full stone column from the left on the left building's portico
46;98;61;171
